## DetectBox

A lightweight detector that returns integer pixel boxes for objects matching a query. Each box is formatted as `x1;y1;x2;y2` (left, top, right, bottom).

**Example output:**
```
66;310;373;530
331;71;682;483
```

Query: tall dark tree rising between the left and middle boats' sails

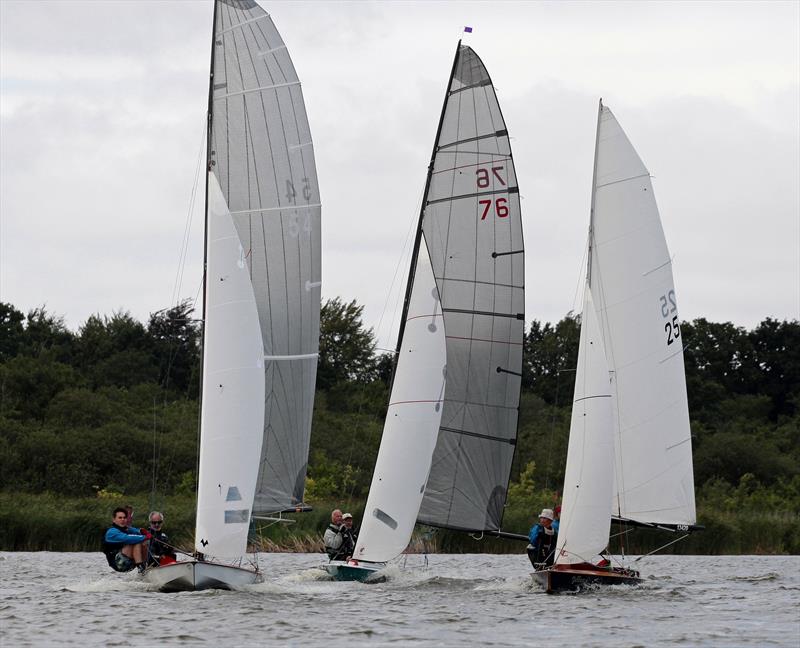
317;297;378;390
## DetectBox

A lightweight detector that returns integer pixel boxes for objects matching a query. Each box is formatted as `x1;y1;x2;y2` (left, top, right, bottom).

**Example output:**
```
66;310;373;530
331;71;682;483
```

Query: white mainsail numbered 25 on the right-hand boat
589;103;696;525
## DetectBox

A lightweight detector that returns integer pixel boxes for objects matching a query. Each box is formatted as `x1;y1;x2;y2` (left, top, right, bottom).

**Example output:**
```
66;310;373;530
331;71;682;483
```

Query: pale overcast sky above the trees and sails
0;0;800;348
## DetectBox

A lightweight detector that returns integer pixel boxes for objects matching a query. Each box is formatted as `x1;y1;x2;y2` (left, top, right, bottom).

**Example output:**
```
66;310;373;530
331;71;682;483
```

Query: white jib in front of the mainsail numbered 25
555;287;614;564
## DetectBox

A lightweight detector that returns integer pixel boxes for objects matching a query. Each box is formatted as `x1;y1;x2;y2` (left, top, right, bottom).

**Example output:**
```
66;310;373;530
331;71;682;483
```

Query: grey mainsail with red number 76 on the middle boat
419;43;525;530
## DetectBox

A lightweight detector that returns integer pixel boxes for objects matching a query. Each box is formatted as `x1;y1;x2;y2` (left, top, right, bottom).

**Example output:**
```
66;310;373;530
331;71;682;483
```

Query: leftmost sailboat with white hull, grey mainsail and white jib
144;0;321;590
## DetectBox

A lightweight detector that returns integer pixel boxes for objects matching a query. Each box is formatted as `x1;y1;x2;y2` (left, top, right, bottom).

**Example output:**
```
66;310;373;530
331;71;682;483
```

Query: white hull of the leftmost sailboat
142;560;261;592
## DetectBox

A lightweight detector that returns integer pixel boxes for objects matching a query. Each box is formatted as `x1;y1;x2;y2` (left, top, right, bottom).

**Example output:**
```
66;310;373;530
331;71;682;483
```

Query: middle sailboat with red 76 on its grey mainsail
325;41;525;580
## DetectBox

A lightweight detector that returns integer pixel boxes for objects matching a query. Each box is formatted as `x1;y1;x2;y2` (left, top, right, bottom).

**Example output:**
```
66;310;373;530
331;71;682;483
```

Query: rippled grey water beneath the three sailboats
0;552;800;648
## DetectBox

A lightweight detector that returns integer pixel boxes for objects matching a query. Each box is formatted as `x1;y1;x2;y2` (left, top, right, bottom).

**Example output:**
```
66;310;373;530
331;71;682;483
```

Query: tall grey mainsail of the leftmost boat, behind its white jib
209;0;321;513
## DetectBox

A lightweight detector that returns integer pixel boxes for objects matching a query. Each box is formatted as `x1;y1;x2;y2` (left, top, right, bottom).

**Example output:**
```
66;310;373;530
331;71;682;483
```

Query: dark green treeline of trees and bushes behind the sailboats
0;298;800;552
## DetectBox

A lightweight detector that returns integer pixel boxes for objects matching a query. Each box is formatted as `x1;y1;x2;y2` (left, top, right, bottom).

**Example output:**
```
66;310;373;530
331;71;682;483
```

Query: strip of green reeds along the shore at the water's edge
0;493;800;555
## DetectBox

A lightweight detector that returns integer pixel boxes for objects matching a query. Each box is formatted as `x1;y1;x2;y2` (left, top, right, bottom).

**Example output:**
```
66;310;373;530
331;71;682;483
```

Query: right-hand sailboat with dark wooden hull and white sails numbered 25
533;101;700;592
